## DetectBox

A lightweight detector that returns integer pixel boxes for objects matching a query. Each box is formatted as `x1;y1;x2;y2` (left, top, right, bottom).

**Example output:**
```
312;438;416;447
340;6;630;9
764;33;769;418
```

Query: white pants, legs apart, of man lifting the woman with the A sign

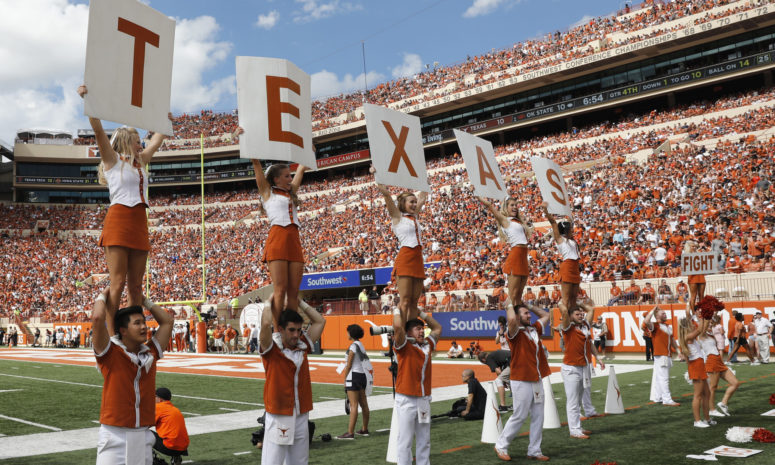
495;380;544;456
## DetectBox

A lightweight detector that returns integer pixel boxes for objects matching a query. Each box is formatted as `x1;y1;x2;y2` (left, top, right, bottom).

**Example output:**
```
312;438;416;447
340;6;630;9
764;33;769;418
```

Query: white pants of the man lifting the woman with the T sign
97;425;156;465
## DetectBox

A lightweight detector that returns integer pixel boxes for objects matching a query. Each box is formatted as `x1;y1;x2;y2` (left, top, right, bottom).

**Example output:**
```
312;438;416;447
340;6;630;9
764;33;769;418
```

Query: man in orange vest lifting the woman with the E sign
258;300;326;465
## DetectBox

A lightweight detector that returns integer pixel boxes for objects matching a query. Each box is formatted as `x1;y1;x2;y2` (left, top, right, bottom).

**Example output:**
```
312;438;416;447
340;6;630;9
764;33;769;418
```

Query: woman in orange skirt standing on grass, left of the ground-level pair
678;318;716;428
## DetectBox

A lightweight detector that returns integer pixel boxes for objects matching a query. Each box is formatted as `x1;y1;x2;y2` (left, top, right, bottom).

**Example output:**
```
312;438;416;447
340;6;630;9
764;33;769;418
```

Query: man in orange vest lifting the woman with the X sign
393;311;441;465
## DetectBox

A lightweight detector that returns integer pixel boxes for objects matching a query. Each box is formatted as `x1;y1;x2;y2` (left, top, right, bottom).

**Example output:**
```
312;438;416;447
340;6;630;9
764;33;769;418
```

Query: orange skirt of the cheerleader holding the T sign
98;203;151;252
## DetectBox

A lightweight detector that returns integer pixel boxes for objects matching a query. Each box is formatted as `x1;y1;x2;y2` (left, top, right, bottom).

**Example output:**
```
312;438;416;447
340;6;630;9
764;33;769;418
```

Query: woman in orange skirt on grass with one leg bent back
700;313;740;417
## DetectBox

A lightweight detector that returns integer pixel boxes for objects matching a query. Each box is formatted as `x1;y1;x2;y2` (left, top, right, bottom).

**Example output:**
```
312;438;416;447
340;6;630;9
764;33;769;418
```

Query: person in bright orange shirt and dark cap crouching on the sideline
153;387;189;465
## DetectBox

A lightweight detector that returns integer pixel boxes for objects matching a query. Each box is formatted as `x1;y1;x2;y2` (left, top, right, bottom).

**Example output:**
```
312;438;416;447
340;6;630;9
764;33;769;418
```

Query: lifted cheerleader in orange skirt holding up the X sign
369;167;428;321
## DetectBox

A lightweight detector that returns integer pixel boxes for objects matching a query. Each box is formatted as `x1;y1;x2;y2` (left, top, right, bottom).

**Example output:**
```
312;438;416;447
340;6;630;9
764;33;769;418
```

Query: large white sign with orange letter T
84;0;175;135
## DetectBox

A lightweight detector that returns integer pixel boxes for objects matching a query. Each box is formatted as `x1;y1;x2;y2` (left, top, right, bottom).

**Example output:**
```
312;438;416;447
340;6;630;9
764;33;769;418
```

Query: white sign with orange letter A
454;129;507;200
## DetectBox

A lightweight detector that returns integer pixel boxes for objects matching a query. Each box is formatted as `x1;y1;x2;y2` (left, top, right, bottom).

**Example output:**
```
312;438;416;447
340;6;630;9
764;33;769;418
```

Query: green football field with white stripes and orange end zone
0;349;775;465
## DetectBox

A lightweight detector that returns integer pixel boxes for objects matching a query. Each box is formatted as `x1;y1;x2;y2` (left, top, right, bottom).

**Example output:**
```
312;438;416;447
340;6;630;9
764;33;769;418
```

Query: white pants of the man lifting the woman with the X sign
395;394;431;465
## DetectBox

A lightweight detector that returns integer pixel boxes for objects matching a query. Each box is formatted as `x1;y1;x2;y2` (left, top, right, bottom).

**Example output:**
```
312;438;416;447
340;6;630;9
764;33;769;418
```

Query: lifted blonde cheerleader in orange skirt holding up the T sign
78;86;172;335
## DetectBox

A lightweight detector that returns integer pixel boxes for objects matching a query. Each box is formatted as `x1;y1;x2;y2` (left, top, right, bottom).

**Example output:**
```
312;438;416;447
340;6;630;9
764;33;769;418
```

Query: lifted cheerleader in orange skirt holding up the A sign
477;197;533;308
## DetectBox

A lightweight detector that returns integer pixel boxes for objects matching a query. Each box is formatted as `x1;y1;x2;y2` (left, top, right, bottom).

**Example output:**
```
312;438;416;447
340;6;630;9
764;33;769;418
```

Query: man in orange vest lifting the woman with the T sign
91;289;174;465
